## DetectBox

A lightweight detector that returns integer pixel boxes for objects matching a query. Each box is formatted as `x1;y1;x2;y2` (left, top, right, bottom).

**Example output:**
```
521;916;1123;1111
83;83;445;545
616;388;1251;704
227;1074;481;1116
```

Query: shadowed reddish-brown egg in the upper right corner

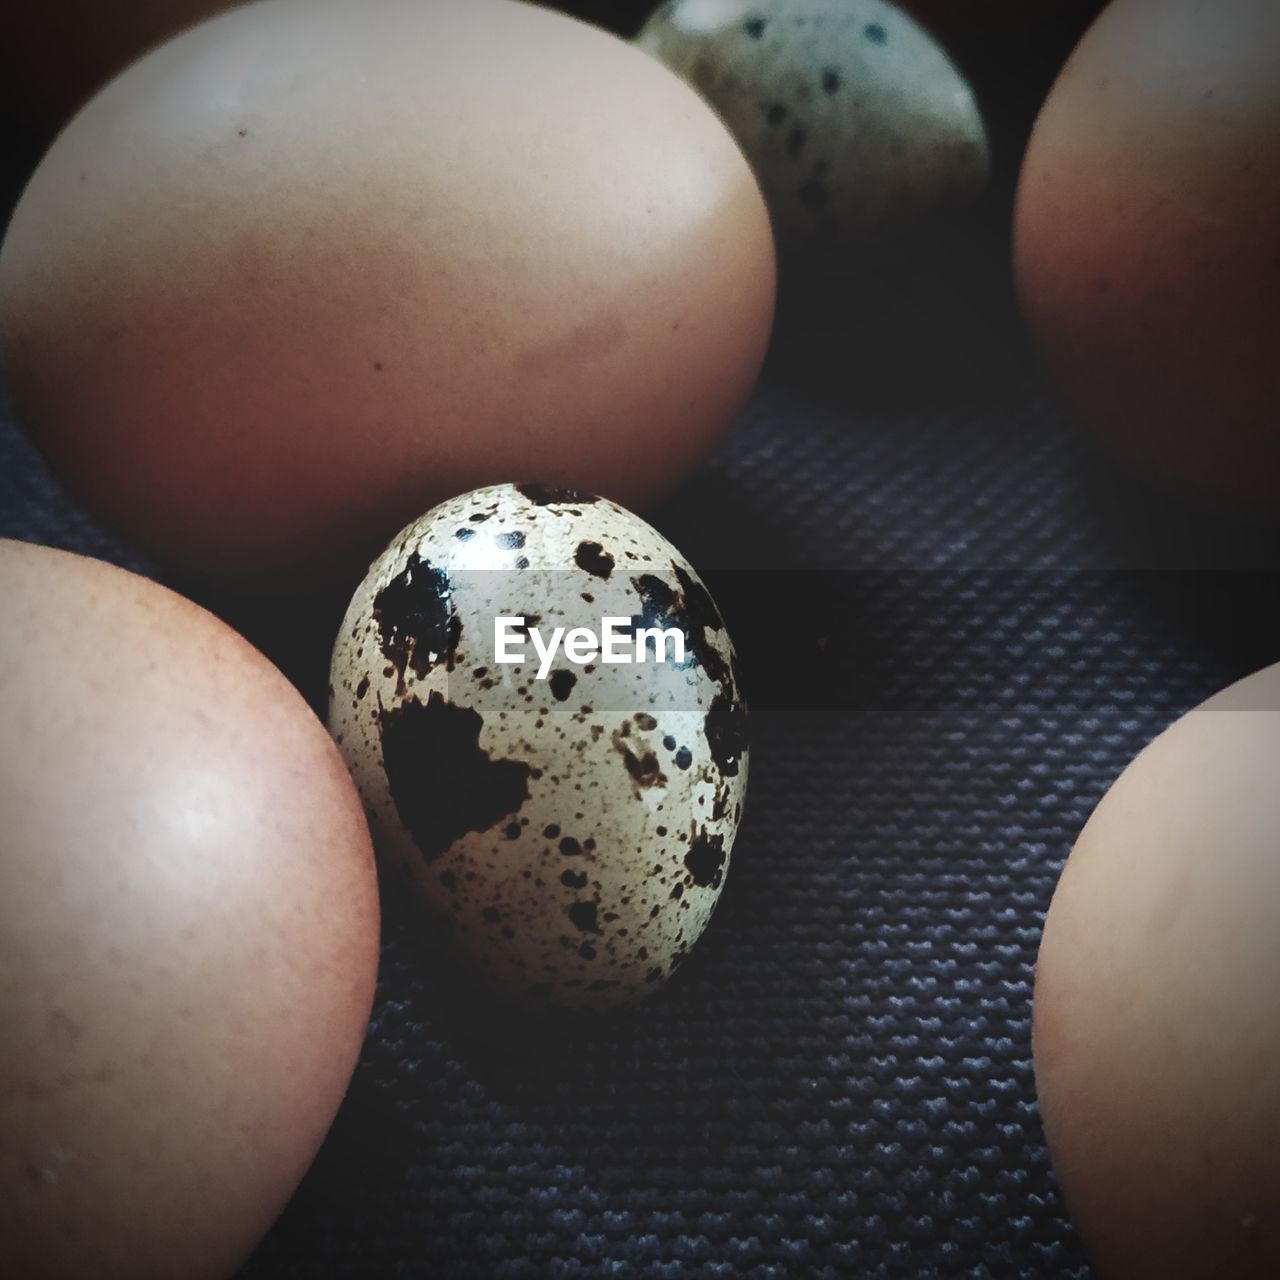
1015;0;1280;506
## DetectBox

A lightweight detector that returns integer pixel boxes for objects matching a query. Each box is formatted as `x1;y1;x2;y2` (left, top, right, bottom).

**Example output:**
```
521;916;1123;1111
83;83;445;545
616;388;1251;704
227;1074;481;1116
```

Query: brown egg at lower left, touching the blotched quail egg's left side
0;541;379;1280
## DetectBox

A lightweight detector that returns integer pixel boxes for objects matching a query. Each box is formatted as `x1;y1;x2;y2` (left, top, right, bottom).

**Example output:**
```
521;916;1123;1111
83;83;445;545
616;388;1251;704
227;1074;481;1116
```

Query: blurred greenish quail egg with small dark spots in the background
636;0;988;274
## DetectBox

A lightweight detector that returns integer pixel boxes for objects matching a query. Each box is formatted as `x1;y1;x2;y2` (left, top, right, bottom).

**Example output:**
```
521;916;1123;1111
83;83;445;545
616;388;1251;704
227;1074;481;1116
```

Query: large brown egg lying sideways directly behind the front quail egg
0;0;774;589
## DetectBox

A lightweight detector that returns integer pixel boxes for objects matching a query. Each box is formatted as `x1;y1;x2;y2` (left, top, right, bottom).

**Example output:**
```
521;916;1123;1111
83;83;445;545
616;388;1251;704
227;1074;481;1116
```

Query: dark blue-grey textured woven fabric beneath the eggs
0;140;1280;1280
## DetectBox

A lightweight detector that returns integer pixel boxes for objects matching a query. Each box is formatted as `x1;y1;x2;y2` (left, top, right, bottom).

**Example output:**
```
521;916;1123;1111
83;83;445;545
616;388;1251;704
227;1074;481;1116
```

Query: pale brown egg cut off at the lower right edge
1033;666;1280;1280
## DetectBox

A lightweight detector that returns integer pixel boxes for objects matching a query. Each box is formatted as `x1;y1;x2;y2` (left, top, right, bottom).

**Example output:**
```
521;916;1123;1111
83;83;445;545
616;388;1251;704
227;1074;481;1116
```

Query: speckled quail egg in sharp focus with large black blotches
329;485;748;1010
